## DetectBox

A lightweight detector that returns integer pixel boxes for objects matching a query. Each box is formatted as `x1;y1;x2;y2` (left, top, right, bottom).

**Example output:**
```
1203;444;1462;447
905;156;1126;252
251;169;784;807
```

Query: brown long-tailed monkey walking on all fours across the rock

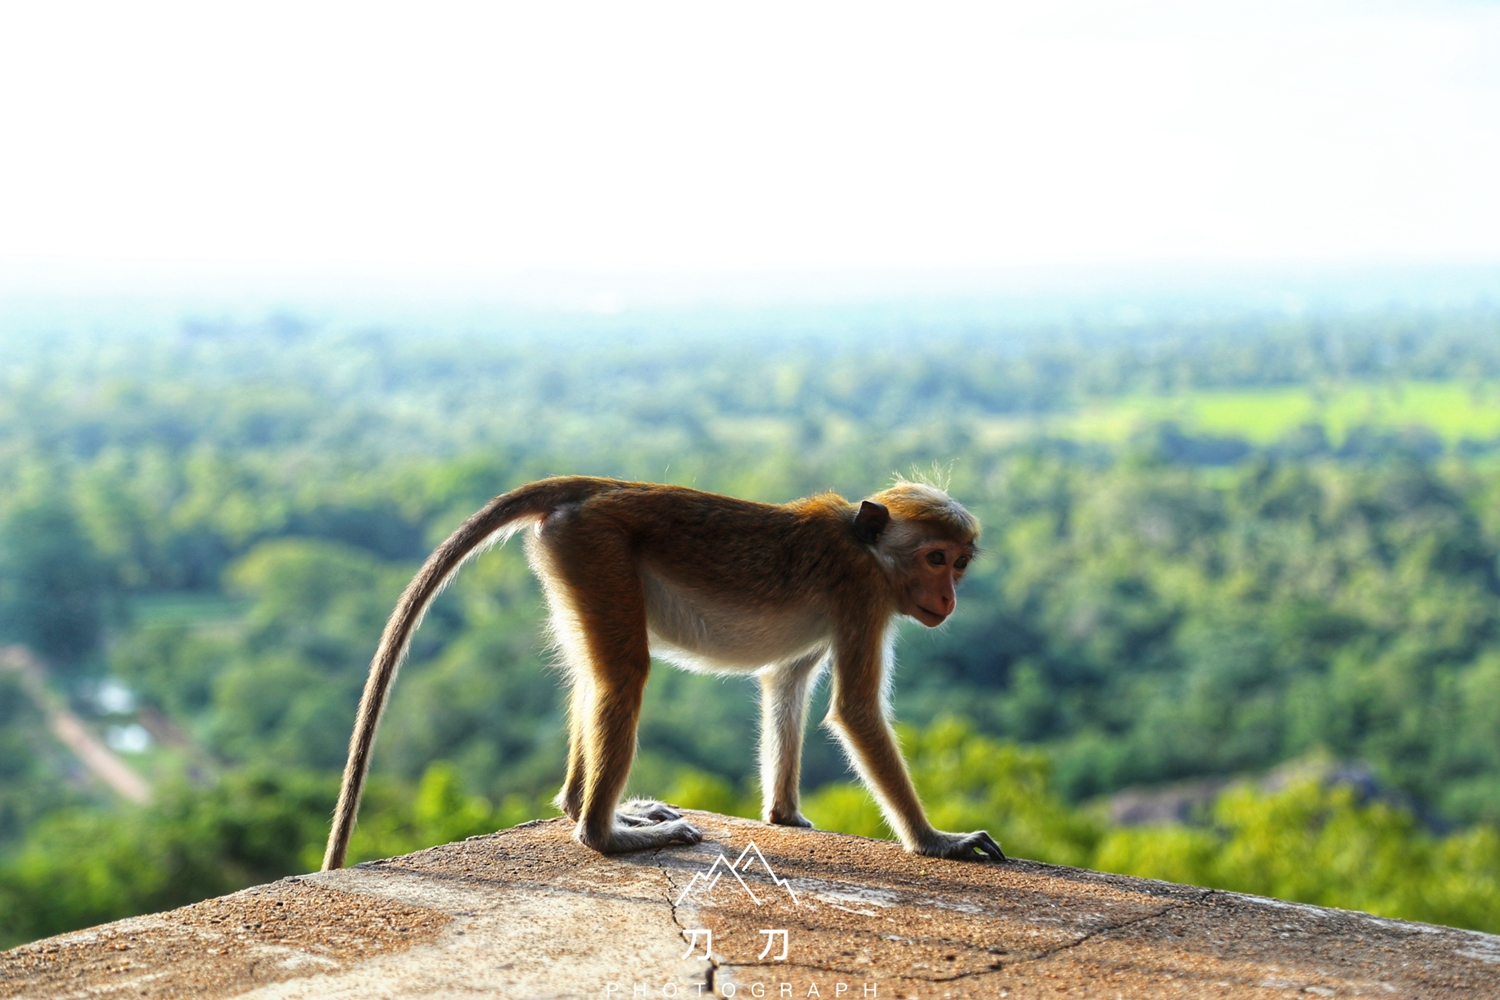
323;477;1007;871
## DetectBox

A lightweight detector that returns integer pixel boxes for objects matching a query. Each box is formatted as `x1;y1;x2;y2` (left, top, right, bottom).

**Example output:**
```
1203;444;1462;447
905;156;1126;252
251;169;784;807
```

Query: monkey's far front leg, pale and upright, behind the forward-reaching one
761;649;827;826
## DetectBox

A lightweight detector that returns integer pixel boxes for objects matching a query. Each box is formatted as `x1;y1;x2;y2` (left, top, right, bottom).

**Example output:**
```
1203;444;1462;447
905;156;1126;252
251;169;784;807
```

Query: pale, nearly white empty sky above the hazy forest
0;0;1500;293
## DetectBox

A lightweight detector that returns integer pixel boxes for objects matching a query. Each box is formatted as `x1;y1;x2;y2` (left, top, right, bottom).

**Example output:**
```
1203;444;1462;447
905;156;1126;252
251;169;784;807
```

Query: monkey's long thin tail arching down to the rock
323;477;602;871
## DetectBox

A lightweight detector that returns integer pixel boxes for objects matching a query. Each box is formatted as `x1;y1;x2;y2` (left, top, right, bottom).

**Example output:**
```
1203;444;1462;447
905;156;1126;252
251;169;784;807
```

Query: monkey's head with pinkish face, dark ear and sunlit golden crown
854;483;980;628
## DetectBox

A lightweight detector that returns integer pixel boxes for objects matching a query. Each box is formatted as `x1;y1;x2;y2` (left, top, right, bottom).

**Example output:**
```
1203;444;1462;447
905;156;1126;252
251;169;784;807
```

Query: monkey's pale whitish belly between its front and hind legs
645;573;828;670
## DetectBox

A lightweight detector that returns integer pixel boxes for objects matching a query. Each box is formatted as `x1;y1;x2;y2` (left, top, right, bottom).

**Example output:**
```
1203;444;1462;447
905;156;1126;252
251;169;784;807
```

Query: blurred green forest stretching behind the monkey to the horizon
0;307;1500;945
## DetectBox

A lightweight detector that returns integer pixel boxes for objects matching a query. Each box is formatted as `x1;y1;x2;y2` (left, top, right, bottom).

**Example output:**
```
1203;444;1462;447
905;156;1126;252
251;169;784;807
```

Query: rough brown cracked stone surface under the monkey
0;813;1500;1000
